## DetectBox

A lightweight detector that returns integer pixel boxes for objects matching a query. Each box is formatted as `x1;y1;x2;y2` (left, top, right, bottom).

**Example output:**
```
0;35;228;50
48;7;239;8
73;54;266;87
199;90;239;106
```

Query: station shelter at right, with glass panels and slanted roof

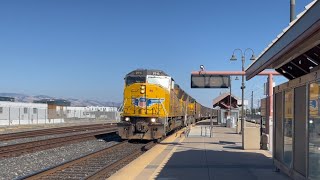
246;0;320;180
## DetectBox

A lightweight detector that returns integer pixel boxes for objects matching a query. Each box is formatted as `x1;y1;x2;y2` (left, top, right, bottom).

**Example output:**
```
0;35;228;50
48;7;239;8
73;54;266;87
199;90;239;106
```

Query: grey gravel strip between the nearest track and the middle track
0;136;118;180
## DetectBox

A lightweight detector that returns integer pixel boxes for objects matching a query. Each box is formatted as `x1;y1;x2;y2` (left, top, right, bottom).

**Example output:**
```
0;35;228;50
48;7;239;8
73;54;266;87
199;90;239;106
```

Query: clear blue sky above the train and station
0;0;311;106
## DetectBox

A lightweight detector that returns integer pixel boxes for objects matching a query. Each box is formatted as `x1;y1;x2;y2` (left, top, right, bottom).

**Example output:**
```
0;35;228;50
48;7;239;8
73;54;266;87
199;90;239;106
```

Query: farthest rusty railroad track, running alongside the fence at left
0;124;116;141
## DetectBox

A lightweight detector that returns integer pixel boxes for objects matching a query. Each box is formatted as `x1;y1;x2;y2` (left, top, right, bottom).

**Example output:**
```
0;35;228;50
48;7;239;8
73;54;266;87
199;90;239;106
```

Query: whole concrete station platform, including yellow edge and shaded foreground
109;121;290;180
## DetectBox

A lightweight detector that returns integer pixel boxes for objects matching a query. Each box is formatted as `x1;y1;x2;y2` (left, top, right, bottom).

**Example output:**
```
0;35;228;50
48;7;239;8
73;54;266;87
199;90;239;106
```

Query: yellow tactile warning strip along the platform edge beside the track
109;130;185;180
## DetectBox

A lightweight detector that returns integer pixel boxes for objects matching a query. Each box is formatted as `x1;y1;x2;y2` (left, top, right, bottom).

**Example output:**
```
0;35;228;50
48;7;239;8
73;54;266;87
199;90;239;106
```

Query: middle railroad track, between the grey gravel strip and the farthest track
0;127;117;158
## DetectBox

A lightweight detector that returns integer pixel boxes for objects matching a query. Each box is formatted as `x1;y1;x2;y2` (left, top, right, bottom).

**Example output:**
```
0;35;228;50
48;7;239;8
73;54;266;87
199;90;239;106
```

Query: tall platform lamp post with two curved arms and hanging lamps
230;48;256;137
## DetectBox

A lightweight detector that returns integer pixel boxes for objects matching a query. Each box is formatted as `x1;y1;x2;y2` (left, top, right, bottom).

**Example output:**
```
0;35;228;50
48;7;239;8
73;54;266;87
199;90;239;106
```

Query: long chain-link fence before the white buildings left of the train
0;107;120;126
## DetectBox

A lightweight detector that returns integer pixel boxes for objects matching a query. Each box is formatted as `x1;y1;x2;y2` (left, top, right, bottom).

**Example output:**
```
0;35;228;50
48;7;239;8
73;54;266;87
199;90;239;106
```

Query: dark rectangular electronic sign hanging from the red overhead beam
191;74;230;88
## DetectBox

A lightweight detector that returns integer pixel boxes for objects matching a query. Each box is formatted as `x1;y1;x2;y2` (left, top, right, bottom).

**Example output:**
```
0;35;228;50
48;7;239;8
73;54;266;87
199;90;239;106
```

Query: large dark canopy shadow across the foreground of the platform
156;149;289;180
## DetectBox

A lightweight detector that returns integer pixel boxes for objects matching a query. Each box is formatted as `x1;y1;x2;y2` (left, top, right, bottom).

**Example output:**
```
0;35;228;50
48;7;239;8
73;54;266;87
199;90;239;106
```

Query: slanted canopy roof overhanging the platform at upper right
246;0;320;80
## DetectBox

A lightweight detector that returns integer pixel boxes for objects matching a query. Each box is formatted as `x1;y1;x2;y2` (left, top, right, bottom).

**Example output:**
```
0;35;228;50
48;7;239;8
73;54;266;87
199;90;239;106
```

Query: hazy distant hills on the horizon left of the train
0;93;121;107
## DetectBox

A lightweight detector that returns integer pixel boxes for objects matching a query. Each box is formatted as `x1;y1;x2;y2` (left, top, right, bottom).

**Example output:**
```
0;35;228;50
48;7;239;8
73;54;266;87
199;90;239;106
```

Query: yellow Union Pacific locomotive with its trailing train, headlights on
118;69;217;140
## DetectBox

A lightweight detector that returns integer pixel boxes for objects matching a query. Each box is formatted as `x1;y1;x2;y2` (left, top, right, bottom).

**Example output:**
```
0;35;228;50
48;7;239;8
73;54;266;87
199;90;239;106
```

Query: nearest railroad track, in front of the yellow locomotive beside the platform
19;141;155;179
